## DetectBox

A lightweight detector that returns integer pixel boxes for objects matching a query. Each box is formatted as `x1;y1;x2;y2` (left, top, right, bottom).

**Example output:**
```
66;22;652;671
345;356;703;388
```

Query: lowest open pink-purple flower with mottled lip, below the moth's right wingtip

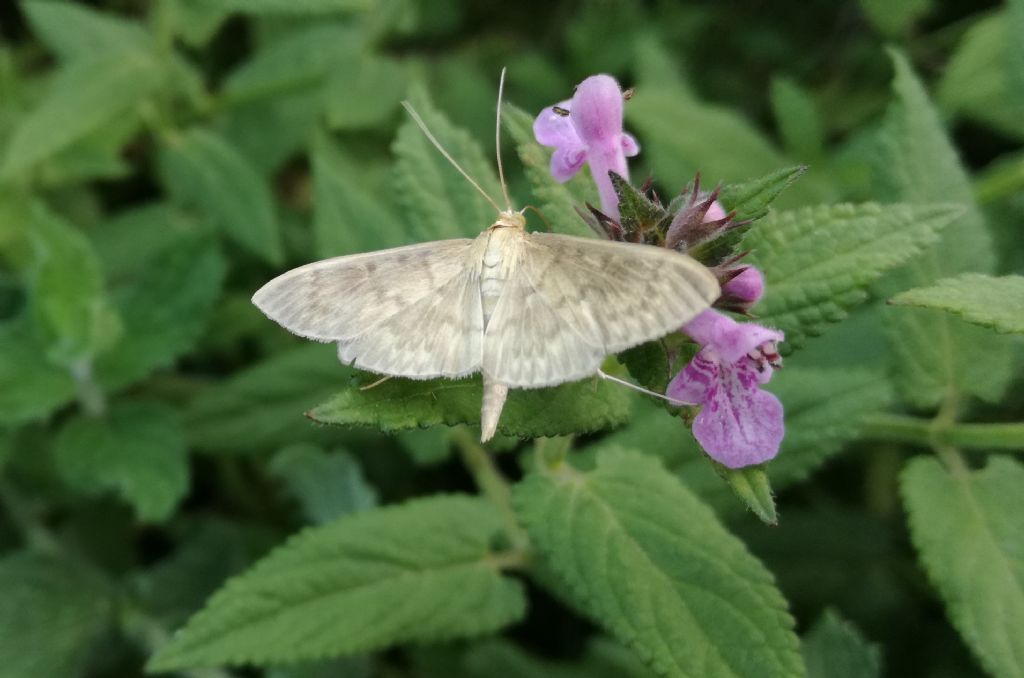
666;310;785;468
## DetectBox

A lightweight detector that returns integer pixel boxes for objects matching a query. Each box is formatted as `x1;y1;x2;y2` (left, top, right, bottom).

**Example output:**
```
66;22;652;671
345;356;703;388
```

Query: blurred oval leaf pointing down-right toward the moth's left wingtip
158;128;285;265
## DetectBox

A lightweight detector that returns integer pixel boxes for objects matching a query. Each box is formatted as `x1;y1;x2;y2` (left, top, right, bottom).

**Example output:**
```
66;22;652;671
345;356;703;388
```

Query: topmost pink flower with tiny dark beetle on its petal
534;75;640;219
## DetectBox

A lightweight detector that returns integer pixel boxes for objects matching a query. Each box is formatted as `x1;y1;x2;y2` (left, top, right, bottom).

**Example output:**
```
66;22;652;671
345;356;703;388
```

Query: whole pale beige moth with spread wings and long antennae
252;71;720;441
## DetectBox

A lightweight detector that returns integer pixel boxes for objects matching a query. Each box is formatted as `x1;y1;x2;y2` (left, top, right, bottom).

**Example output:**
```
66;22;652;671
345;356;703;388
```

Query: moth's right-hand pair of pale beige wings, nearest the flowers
483;234;719;388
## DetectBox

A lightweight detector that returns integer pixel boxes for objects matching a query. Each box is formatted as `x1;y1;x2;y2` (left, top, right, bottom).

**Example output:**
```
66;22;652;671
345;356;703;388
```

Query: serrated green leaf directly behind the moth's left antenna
391;87;502;240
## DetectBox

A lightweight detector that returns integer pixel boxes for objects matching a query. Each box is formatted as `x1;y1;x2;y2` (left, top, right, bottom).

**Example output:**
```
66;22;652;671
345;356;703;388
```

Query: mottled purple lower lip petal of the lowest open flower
693;368;785;468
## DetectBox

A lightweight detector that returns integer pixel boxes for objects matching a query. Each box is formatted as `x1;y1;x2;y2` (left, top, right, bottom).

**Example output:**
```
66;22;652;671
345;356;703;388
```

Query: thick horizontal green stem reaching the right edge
864;414;1024;452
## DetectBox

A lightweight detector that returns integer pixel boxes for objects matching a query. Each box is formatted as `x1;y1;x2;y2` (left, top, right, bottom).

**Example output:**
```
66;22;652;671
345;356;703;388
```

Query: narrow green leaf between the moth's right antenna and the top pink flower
502;103;600;237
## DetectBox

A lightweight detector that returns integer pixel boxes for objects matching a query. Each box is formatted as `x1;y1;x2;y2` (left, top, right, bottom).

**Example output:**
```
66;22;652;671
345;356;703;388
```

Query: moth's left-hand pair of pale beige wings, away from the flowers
253;239;483;379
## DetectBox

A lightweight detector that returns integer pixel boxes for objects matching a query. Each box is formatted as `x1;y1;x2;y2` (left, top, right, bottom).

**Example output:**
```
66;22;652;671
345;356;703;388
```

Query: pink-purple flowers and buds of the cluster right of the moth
534;75;784;468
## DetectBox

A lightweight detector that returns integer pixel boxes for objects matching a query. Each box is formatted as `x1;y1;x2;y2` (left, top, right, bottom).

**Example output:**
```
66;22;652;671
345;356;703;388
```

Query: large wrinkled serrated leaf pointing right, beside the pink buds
743;203;964;350
